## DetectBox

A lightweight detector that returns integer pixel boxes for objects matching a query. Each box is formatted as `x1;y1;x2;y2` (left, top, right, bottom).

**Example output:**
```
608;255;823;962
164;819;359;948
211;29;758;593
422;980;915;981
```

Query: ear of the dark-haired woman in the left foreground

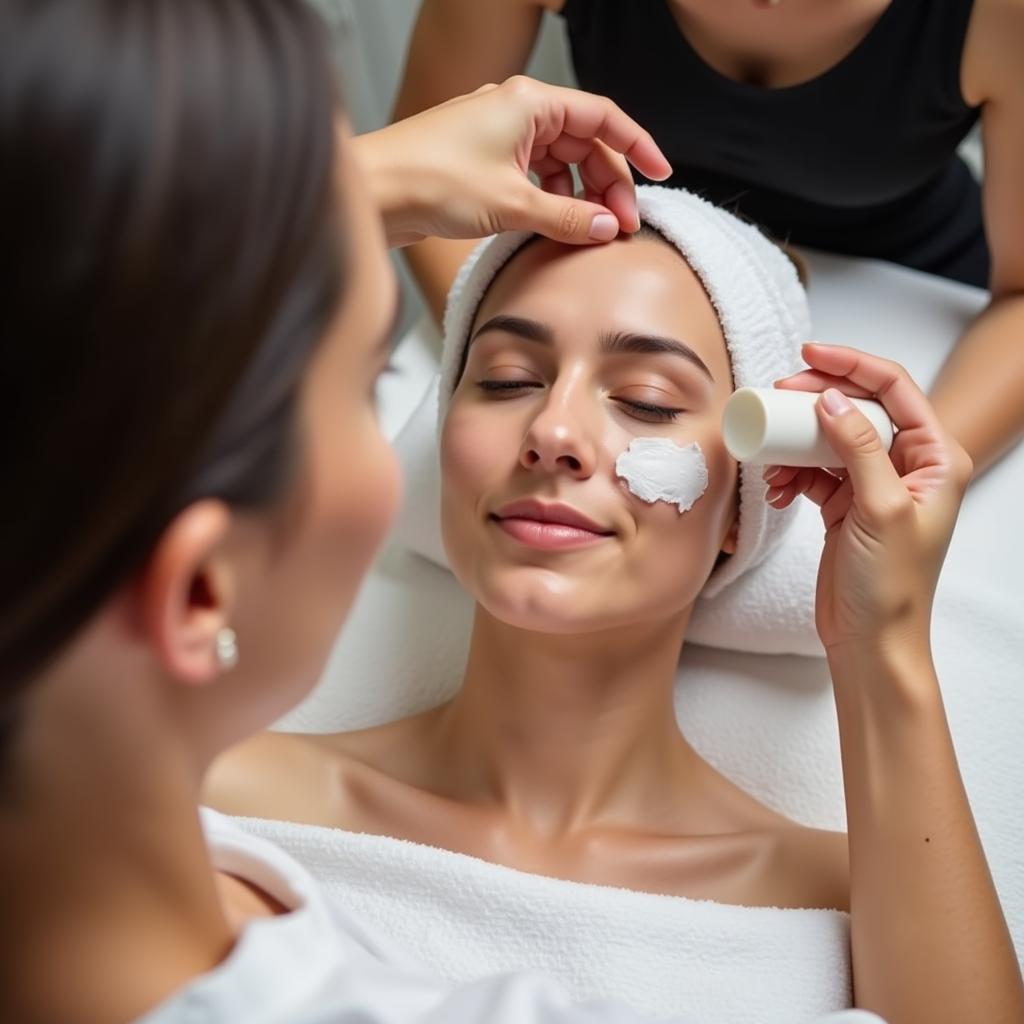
137;500;237;686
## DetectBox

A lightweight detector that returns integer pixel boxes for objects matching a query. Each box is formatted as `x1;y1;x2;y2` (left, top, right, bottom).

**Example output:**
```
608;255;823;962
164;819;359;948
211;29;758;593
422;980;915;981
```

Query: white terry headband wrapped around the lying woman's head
438;185;811;598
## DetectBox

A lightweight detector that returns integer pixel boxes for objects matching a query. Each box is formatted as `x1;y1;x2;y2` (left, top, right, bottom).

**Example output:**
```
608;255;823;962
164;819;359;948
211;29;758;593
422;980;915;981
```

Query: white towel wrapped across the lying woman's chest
236;818;860;1024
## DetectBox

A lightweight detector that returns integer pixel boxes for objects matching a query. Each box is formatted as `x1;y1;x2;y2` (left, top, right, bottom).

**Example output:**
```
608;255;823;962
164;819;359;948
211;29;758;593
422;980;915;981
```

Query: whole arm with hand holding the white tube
771;345;1024;1024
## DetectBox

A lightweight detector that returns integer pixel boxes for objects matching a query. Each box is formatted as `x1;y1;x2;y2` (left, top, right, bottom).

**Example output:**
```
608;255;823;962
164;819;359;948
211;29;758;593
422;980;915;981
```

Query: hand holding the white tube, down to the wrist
765;344;972;655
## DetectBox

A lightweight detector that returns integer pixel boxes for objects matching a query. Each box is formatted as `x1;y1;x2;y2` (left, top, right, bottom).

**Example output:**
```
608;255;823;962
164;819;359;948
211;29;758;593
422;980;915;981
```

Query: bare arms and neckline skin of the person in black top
395;0;1024;473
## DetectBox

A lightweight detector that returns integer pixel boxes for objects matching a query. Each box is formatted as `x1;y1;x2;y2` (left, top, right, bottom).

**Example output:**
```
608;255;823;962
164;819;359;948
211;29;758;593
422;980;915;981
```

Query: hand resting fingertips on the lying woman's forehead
356;75;672;245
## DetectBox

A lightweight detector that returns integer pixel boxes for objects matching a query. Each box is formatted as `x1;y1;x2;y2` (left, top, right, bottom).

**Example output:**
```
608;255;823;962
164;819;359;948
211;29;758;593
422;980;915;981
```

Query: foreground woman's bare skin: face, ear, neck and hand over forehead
0;83;659;1024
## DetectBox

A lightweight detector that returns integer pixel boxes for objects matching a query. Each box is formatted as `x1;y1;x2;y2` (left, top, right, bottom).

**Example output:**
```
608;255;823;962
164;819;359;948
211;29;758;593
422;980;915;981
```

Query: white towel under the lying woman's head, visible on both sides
393;378;824;655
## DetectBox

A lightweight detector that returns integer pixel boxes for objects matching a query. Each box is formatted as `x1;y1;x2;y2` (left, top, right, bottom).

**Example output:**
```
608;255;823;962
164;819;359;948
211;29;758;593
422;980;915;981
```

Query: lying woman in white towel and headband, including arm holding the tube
208;188;1020;1024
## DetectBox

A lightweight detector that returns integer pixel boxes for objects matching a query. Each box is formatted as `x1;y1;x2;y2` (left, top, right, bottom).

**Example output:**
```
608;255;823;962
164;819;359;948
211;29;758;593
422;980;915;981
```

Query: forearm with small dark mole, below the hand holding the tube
829;649;1024;1024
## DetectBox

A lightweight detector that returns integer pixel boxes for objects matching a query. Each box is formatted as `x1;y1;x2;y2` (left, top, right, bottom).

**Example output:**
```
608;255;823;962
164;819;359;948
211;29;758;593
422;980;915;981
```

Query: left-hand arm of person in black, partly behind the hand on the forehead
393;0;557;324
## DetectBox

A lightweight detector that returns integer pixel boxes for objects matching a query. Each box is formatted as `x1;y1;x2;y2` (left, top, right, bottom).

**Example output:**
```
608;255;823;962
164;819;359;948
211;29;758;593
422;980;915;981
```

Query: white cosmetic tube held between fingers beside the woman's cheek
722;387;894;468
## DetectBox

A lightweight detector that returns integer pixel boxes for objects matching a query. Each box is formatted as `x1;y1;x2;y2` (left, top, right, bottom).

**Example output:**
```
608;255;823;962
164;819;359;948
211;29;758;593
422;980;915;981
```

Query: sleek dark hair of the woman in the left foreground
0;0;345;712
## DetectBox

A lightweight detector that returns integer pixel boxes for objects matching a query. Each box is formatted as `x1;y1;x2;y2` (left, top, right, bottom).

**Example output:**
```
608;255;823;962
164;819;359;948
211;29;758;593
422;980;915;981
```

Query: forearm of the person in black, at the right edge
931;294;1024;475
